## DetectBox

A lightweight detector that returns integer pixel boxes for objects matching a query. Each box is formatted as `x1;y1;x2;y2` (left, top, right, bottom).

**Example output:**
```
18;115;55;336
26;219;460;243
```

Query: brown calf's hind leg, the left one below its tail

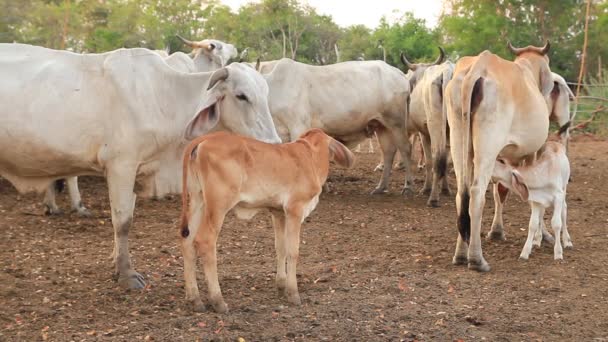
181;193;205;312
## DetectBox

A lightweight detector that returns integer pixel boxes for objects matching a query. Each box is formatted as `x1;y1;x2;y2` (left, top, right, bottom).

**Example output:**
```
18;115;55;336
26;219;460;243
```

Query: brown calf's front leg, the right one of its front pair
285;207;302;305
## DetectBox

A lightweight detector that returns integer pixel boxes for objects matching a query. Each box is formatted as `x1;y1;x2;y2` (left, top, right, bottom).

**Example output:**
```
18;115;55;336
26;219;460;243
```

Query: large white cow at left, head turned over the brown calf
0;44;280;288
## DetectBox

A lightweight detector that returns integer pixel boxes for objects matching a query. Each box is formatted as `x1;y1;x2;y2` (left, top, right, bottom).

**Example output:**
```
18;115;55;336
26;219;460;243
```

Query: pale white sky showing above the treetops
221;0;442;28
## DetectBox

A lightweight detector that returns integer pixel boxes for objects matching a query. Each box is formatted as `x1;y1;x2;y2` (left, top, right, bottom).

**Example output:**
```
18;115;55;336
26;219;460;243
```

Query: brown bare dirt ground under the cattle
0;137;608;341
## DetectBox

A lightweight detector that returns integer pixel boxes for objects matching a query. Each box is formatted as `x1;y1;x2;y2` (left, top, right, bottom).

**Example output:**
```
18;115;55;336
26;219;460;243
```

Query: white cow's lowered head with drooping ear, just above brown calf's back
184;63;281;143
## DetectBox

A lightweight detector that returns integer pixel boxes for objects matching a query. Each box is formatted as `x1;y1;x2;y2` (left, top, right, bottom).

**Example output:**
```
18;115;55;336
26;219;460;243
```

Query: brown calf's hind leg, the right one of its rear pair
195;203;228;313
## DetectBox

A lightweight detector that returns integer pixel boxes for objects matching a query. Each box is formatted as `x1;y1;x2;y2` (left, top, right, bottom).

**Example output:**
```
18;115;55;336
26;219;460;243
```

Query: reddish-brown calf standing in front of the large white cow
180;129;353;312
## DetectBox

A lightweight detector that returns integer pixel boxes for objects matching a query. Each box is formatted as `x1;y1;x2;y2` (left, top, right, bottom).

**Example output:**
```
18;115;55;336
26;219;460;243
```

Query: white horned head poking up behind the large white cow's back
177;35;238;71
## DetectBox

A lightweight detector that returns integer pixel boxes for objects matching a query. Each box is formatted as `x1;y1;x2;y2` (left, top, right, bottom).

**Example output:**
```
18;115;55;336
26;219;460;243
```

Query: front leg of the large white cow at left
106;165;146;289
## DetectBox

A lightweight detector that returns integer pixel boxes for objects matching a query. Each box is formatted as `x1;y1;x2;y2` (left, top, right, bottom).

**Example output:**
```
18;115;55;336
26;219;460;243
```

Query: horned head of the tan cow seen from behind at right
507;40;553;97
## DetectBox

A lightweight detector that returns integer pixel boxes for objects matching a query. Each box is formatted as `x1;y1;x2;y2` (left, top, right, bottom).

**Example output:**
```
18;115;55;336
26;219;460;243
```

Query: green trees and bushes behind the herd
0;0;608;80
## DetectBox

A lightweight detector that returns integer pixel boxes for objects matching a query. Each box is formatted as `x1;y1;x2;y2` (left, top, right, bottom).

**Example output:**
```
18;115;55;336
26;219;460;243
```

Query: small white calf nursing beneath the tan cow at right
492;141;572;260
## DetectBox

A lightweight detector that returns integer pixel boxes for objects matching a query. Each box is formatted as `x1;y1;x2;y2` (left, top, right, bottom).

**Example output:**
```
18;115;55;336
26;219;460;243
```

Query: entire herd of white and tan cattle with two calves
0;37;572;312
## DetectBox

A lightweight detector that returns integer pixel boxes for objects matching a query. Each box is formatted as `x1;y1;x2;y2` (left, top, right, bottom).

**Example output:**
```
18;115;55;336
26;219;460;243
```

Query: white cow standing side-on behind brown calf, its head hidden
264;58;412;194
